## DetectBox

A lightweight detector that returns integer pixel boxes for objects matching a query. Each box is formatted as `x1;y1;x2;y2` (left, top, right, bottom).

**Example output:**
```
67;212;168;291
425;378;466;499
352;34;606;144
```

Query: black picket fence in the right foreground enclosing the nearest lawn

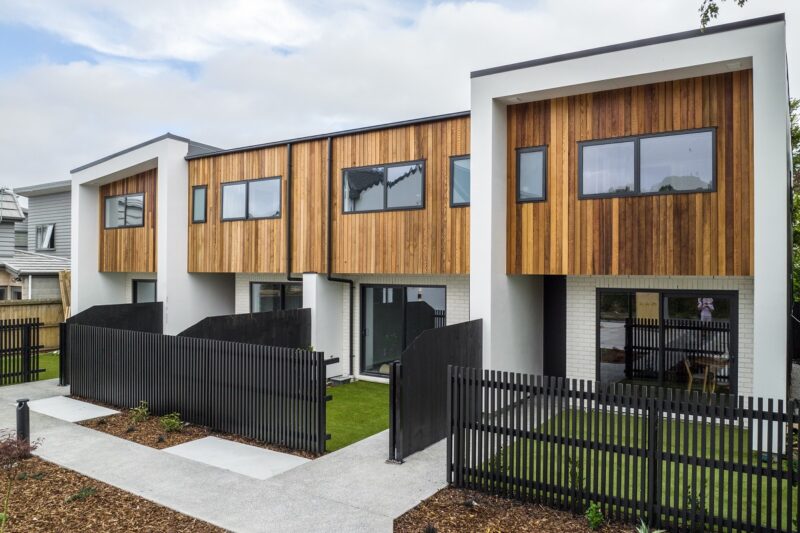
447;367;800;533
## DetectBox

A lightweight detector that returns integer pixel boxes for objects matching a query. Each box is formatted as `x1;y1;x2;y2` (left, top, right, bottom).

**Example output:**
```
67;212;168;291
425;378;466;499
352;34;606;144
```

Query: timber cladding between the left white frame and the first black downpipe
186;146;287;272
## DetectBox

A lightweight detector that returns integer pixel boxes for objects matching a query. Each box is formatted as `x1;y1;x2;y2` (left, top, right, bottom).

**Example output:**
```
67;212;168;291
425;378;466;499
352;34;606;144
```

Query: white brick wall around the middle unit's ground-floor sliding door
342;275;469;375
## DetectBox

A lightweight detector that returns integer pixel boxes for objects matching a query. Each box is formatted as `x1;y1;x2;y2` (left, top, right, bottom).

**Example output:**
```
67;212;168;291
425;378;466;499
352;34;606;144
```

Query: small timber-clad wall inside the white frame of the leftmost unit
98;169;158;272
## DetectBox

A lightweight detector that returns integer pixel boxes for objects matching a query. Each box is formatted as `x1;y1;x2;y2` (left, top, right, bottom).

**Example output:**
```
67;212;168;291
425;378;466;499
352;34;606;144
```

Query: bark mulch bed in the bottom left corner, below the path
0;457;224;533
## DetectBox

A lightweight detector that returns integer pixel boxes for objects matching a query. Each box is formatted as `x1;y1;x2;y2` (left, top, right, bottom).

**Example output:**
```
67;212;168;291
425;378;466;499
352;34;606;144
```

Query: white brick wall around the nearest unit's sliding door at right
567;276;753;395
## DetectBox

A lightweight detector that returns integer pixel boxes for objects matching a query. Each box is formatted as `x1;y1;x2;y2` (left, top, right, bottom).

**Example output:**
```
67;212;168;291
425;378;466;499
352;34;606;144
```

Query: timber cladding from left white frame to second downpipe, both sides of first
186;140;327;273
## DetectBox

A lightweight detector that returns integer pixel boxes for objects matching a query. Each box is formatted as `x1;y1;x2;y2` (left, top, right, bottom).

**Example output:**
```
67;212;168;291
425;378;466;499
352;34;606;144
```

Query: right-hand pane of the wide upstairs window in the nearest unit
639;130;714;192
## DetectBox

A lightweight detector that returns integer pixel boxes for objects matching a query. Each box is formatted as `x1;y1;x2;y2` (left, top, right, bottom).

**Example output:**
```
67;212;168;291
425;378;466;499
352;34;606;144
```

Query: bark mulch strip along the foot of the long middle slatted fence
72;396;317;459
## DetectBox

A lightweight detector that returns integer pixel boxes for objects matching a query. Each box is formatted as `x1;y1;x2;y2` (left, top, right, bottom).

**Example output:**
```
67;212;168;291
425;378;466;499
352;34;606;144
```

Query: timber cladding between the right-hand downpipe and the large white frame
332;117;470;274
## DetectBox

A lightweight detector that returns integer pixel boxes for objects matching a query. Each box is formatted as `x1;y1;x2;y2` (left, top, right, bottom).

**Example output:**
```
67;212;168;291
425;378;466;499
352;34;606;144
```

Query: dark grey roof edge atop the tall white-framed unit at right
470;13;786;78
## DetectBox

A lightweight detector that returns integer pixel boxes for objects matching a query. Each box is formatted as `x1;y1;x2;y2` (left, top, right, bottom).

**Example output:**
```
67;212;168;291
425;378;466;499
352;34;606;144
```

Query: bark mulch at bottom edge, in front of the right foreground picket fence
394;488;633;533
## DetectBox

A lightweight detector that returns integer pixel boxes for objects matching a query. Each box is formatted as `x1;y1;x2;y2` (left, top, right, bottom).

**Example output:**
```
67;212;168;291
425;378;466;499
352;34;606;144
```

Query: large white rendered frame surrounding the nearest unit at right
470;22;789;398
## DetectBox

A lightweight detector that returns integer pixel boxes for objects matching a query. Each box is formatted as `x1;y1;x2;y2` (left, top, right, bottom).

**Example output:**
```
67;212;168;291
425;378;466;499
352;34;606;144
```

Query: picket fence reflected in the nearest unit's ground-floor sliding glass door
625;318;736;392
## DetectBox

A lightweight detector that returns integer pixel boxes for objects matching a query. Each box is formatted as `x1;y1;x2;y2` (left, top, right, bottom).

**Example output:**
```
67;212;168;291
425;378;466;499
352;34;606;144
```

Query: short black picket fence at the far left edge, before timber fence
0;318;44;385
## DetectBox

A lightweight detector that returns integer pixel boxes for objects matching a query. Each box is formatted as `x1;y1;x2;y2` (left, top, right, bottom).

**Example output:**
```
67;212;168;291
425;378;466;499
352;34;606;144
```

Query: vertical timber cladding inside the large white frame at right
507;70;753;276
